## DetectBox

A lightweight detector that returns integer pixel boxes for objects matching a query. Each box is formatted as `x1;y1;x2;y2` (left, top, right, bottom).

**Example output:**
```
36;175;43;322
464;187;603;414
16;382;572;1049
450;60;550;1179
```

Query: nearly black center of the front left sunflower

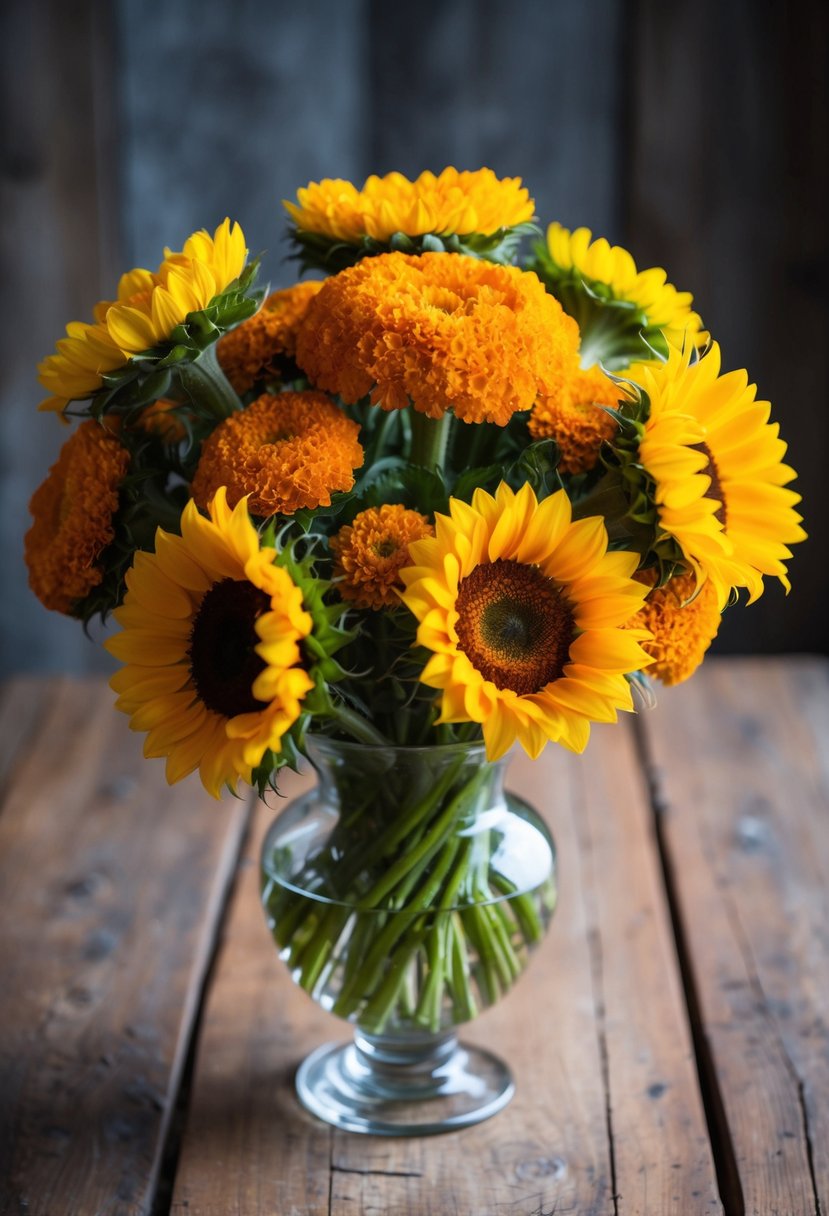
190;579;271;717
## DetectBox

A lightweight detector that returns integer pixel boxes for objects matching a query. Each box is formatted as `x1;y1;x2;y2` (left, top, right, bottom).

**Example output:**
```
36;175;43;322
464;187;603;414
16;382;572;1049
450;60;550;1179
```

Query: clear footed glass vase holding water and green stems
261;736;557;1135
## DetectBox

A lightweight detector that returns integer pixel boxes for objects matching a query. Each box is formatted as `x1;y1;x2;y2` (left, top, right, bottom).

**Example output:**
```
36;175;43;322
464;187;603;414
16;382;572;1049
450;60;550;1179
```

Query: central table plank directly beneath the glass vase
173;728;720;1216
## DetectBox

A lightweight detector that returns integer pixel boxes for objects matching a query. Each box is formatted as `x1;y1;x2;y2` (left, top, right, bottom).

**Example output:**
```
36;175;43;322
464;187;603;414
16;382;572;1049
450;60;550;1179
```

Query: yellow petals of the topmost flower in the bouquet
283;168;535;243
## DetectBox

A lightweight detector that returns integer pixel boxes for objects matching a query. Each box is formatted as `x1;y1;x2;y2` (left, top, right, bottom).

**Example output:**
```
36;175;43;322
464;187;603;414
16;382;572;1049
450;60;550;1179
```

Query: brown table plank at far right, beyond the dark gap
643;659;829;1216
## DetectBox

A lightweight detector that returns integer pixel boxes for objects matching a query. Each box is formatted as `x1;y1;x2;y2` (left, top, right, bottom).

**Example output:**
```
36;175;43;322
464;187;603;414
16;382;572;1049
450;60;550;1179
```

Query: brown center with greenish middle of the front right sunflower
456;558;575;696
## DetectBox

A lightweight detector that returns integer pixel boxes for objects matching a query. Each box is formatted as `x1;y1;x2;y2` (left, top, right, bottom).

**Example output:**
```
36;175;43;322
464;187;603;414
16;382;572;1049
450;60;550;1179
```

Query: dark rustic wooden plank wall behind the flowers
0;0;829;674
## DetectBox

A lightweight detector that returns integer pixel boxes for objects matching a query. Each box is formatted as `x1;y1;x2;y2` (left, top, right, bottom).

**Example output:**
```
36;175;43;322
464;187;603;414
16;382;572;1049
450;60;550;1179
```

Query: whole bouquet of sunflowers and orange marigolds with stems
26;169;805;1029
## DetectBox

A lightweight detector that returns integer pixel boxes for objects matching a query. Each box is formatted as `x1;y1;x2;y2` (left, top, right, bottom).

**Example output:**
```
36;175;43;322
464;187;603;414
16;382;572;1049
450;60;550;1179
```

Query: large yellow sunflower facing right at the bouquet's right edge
628;343;806;608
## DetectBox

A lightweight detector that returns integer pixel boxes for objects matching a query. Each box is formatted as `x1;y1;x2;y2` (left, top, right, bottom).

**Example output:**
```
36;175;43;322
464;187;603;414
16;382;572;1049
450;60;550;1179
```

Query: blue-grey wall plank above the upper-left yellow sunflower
114;0;368;279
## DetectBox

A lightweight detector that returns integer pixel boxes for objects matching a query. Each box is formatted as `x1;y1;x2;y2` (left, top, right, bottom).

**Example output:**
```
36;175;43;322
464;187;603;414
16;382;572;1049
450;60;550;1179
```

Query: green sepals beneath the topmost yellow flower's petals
288;223;540;275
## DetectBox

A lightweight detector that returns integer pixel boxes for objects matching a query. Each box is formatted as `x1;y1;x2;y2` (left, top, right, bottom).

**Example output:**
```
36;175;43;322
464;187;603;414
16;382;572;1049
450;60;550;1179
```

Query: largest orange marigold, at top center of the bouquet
297;253;579;426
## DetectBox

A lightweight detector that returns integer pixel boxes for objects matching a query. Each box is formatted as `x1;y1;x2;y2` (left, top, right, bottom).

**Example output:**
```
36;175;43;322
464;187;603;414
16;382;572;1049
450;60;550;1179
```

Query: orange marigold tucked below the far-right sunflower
630;570;722;685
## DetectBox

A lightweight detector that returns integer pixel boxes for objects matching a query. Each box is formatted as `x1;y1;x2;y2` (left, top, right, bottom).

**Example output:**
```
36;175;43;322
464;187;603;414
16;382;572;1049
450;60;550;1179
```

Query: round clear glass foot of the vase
297;1031;515;1136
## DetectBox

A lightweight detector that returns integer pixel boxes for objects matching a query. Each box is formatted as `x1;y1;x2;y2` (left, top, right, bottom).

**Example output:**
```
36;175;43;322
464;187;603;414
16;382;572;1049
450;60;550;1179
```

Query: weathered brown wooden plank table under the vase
0;658;829;1216
